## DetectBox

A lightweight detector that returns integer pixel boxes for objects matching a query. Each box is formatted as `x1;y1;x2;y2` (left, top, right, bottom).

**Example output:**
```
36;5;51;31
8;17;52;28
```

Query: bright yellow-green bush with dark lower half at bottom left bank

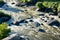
0;23;11;40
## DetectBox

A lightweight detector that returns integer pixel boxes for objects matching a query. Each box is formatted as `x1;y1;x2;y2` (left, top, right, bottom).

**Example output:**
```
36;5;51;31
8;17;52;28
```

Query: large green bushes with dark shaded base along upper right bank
36;0;60;14
